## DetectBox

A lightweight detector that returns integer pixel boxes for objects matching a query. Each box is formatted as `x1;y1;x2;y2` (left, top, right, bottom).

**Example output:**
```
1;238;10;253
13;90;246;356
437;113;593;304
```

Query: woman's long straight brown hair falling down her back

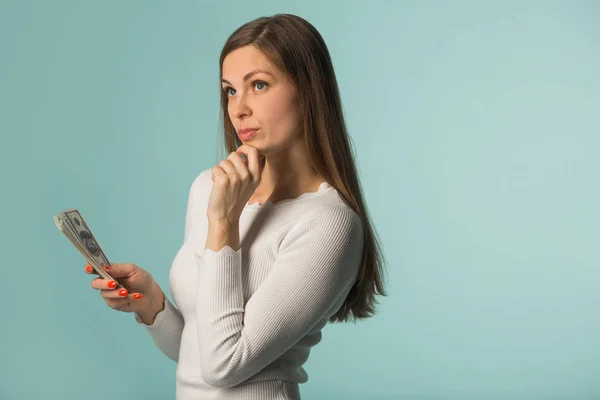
219;14;387;322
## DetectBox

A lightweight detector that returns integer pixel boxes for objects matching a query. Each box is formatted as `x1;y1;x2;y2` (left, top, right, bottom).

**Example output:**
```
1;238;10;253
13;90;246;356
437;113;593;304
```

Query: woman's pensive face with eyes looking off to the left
221;46;300;155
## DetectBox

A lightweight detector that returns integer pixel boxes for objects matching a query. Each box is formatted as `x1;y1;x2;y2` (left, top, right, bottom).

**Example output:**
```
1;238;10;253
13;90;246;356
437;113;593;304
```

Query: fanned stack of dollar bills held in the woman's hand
54;209;125;289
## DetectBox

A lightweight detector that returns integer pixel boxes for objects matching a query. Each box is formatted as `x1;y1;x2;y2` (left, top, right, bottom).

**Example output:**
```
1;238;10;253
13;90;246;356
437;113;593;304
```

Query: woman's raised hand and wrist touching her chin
206;144;264;224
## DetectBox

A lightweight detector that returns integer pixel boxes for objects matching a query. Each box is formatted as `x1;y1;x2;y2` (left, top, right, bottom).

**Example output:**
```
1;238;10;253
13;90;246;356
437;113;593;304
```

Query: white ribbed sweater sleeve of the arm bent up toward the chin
195;204;364;387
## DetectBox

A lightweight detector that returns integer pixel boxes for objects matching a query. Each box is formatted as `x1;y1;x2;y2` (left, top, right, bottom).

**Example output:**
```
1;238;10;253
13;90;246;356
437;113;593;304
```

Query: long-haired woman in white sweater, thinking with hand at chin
89;14;386;400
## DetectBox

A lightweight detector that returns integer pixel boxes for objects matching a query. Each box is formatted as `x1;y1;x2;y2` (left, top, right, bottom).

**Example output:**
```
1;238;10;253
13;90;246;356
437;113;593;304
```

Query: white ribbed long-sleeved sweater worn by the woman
134;169;364;400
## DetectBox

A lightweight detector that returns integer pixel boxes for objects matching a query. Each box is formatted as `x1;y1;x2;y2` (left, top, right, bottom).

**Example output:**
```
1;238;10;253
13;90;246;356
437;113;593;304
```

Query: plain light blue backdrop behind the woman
0;0;600;400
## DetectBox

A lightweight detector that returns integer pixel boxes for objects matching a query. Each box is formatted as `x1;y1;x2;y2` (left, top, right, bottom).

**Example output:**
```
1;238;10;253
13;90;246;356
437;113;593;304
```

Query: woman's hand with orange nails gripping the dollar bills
85;263;164;319
